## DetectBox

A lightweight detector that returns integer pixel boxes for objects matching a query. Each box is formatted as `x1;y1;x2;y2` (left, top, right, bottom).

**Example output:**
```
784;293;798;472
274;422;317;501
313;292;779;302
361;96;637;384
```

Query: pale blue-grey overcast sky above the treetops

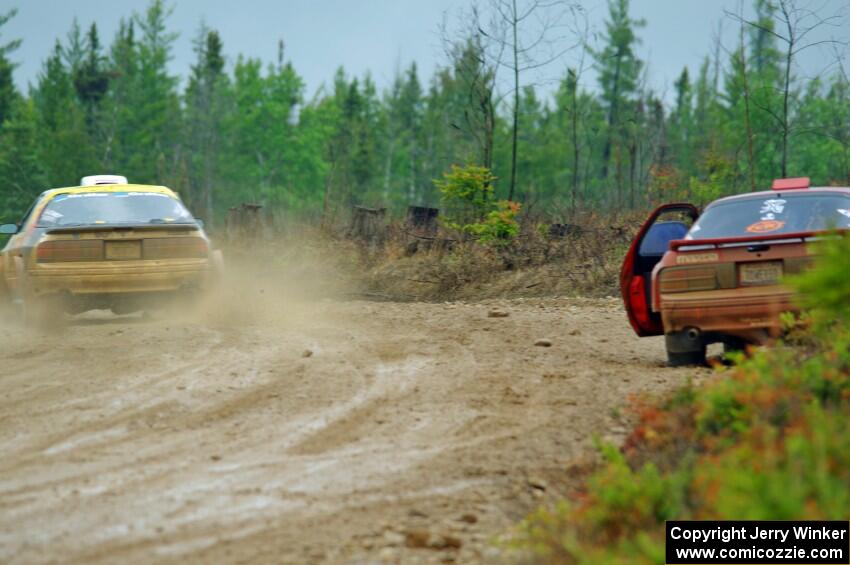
0;0;850;103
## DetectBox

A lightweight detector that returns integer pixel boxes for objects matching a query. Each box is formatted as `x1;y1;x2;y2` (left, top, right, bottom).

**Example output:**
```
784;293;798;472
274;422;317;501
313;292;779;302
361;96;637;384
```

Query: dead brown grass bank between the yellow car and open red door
219;210;642;301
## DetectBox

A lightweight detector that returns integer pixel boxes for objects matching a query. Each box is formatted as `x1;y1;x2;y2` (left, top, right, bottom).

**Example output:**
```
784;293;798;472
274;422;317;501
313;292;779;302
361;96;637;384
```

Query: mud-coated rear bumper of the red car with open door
661;285;797;341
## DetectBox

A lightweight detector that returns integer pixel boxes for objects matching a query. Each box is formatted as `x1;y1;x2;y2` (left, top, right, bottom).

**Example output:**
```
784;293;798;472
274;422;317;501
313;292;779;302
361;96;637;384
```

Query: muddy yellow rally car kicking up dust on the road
0;175;222;321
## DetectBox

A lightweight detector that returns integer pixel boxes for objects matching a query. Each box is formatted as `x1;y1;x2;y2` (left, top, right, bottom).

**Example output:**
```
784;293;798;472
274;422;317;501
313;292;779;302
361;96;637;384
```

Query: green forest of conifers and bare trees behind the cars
0;0;850;228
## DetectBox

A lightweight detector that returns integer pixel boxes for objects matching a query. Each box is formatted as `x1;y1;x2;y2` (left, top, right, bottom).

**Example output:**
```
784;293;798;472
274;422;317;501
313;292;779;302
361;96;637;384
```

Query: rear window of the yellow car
38;192;194;227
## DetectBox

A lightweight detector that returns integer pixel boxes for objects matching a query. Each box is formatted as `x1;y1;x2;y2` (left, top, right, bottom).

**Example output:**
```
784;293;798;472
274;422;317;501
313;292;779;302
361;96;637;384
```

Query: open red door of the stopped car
620;203;699;337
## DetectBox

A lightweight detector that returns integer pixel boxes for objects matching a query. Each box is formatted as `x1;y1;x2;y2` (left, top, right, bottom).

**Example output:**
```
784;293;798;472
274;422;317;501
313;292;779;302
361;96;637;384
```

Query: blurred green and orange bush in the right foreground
513;232;850;563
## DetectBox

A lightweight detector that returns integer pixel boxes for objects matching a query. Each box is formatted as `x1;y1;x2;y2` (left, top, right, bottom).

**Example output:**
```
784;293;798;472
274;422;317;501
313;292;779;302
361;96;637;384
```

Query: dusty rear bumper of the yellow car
27;259;210;296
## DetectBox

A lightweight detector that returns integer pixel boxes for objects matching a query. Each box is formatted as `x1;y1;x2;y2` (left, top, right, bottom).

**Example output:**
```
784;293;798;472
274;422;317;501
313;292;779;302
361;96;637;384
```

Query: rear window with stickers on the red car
685;193;850;239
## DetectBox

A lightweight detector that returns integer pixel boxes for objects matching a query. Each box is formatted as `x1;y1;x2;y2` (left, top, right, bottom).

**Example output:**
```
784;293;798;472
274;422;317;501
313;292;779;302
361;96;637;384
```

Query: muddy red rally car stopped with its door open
620;178;850;366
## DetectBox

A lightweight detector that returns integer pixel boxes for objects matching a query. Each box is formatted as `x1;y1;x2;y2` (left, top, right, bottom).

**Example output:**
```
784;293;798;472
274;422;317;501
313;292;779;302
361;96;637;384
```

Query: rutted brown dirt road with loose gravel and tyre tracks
0;299;705;563
